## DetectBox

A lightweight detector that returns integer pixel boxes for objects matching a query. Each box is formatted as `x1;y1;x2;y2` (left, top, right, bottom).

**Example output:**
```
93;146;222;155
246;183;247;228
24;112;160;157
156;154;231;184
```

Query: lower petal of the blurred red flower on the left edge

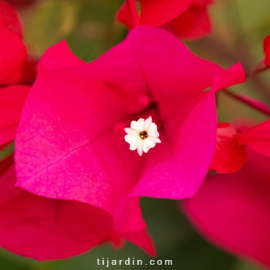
0;85;30;145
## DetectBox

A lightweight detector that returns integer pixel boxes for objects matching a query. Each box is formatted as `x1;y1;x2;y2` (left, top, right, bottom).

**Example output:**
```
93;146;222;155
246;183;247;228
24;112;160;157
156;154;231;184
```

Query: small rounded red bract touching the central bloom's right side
211;123;247;173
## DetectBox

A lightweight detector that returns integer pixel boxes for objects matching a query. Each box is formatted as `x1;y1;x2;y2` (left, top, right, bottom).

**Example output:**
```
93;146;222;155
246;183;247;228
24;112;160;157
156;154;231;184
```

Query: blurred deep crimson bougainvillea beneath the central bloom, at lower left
0;156;154;260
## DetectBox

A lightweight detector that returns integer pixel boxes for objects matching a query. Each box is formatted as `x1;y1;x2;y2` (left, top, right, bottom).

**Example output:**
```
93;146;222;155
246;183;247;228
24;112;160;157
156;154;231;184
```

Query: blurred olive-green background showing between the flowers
0;0;270;270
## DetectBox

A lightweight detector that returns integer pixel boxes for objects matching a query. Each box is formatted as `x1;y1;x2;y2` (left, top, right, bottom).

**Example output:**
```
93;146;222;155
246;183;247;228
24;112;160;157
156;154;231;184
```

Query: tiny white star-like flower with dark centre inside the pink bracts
125;116;161;156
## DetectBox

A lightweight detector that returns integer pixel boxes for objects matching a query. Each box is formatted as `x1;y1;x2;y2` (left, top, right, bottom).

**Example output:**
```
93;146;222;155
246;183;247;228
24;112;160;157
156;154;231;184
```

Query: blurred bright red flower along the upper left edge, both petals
0;1;37;145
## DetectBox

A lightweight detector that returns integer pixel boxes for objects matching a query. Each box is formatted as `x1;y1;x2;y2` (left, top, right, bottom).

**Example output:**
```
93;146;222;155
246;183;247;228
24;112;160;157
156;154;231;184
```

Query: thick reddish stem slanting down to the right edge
222;89;270;117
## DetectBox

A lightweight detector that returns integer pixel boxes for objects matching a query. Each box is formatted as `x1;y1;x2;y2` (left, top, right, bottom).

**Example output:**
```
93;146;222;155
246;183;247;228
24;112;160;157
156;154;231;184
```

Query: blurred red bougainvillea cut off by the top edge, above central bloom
117;0;212;39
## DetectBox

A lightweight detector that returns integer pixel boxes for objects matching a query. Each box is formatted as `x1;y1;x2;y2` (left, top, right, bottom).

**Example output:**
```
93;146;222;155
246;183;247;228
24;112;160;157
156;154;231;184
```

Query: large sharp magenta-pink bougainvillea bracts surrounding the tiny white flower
15;26;245;246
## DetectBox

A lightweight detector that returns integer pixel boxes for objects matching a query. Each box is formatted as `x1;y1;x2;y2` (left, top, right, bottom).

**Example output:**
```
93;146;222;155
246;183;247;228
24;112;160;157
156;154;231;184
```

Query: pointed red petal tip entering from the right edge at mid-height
236;120;270;157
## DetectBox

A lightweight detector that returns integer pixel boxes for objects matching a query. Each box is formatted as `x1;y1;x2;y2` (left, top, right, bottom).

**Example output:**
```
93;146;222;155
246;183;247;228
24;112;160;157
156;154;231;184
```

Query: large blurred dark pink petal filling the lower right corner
182;149;270;267
